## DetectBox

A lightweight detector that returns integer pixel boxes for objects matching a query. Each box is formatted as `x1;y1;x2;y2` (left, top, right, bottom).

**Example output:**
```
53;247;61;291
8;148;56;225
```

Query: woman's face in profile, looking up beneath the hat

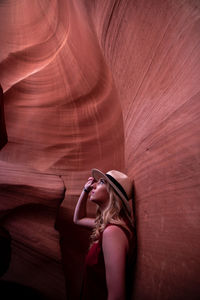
90;178;109;208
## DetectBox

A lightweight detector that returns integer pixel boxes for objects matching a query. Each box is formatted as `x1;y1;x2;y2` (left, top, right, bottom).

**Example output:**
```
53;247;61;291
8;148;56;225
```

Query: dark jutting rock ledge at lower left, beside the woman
0;161;66;299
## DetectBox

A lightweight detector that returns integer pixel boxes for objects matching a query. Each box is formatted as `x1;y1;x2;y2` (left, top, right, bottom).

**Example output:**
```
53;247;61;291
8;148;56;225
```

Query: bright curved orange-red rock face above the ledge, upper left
0;0;123;174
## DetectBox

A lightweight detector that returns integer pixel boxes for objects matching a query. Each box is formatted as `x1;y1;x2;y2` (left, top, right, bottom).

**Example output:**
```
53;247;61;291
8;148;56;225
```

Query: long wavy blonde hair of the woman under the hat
90;183;133;247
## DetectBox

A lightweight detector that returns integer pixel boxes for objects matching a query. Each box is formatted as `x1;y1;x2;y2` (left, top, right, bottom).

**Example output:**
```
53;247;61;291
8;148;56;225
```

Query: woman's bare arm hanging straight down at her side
102;225;129;300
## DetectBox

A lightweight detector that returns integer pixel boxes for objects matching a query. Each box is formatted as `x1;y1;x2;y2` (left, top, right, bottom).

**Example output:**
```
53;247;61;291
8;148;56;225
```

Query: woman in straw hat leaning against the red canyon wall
74;169;135;300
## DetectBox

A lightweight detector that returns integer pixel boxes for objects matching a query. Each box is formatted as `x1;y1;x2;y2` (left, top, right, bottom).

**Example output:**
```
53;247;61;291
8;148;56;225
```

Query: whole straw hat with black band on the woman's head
92;169;133;217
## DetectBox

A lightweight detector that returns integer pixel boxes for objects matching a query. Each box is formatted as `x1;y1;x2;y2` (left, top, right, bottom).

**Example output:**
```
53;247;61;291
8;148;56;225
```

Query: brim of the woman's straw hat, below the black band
92;169;131;218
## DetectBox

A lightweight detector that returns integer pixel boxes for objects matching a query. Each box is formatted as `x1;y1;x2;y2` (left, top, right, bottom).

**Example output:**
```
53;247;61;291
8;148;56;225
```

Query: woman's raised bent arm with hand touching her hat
73;177;95;228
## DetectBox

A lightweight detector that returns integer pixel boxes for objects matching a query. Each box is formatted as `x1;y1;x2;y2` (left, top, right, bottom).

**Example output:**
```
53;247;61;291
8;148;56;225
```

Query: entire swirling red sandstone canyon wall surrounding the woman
0;0;200;300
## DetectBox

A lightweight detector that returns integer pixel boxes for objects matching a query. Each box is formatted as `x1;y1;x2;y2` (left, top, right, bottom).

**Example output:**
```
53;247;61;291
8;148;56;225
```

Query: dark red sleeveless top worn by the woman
81;224;135;300
